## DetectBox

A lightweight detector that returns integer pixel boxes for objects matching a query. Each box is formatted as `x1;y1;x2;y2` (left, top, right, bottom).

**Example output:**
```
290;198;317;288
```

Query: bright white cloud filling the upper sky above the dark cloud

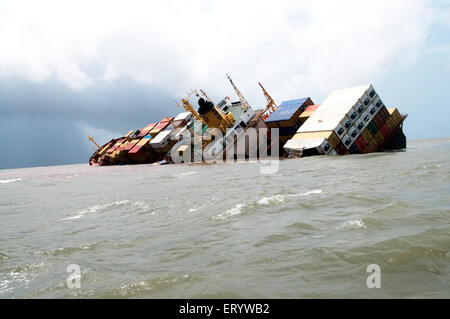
0;0;431;106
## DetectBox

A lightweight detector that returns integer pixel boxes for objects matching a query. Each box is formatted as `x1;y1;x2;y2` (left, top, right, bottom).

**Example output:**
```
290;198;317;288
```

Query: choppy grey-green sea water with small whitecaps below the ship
0;139;450;298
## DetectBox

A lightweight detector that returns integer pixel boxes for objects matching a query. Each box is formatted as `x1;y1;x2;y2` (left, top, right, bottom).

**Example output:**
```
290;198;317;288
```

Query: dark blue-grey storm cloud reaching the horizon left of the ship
0;79;182;169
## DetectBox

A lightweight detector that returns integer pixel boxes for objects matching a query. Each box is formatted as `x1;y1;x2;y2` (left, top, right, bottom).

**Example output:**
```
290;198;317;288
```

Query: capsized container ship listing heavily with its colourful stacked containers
89;76;407;166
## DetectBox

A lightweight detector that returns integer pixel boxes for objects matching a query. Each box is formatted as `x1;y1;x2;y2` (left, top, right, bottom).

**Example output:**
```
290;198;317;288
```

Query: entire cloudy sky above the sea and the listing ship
0;0;450;169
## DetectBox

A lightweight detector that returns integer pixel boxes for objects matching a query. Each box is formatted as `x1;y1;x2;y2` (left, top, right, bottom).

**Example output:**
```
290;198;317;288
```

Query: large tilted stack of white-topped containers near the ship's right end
284;85;391;155
